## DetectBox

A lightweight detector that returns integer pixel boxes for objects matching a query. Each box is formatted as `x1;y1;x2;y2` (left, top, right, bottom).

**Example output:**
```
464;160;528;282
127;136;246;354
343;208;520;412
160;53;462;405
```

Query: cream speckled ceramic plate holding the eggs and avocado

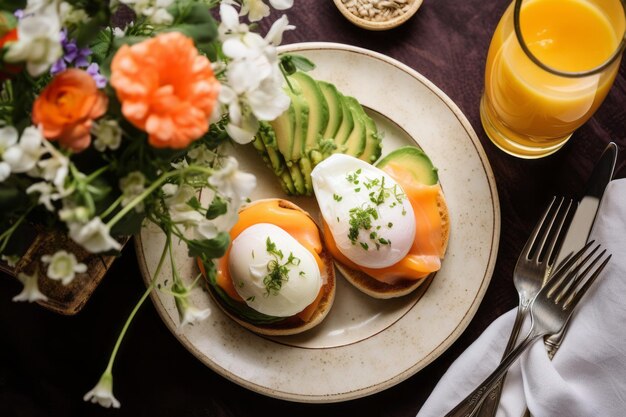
136;43;500;403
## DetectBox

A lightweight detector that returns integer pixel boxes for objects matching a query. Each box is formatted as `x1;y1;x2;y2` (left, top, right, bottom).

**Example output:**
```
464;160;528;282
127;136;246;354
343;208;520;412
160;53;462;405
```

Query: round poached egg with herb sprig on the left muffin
228;223;322;317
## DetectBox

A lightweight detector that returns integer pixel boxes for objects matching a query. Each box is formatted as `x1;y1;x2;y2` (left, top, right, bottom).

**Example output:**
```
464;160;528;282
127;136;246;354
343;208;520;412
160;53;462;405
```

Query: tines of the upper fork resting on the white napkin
546;240;612;310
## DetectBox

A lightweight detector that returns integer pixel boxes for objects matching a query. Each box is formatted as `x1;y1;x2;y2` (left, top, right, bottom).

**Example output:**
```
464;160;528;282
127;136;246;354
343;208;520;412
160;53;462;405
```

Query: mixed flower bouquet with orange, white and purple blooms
0;0;304;407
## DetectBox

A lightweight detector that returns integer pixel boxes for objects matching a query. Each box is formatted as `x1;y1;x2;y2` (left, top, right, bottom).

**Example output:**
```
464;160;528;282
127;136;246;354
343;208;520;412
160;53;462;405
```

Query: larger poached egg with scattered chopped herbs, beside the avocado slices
311;154;415;268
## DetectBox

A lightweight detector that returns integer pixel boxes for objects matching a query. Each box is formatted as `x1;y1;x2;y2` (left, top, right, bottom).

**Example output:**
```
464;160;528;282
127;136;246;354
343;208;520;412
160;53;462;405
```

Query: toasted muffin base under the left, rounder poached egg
207;198;336;336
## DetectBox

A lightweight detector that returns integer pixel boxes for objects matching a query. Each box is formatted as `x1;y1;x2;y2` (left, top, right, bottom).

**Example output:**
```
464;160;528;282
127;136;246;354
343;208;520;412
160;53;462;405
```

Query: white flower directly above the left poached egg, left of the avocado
209;157;256;207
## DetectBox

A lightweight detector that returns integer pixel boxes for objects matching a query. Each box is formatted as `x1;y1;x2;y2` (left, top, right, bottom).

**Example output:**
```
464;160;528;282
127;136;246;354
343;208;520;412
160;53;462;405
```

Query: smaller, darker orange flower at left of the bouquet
33;68;108;152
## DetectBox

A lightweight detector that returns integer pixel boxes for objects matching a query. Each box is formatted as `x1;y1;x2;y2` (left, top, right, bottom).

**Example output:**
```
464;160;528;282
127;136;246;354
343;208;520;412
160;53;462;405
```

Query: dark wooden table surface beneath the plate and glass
0;0;626;417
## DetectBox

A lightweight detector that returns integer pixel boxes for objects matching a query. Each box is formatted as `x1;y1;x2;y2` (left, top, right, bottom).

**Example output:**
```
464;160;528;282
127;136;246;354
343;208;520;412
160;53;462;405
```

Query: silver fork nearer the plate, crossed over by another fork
476;197;572;417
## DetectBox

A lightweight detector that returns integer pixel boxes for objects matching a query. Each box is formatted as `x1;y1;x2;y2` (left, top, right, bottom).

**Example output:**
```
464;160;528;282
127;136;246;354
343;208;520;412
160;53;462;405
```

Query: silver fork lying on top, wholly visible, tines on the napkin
445;241;611;417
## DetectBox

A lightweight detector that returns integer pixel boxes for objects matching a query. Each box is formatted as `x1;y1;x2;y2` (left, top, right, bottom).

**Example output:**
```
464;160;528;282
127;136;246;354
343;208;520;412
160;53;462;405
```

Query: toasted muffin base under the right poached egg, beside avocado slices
335;189;450;299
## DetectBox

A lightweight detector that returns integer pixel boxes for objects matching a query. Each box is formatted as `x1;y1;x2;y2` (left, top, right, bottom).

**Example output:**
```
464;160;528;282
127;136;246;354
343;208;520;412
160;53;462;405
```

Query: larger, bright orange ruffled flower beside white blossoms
110;32;220;149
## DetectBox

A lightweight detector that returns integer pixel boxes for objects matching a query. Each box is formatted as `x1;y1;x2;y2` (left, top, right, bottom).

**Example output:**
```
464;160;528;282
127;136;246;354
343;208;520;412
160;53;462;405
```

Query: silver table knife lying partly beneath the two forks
523;142;617;417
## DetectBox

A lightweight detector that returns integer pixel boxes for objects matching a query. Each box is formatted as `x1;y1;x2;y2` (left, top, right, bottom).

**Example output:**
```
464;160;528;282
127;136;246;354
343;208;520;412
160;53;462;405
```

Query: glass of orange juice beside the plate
480;0;626;158
